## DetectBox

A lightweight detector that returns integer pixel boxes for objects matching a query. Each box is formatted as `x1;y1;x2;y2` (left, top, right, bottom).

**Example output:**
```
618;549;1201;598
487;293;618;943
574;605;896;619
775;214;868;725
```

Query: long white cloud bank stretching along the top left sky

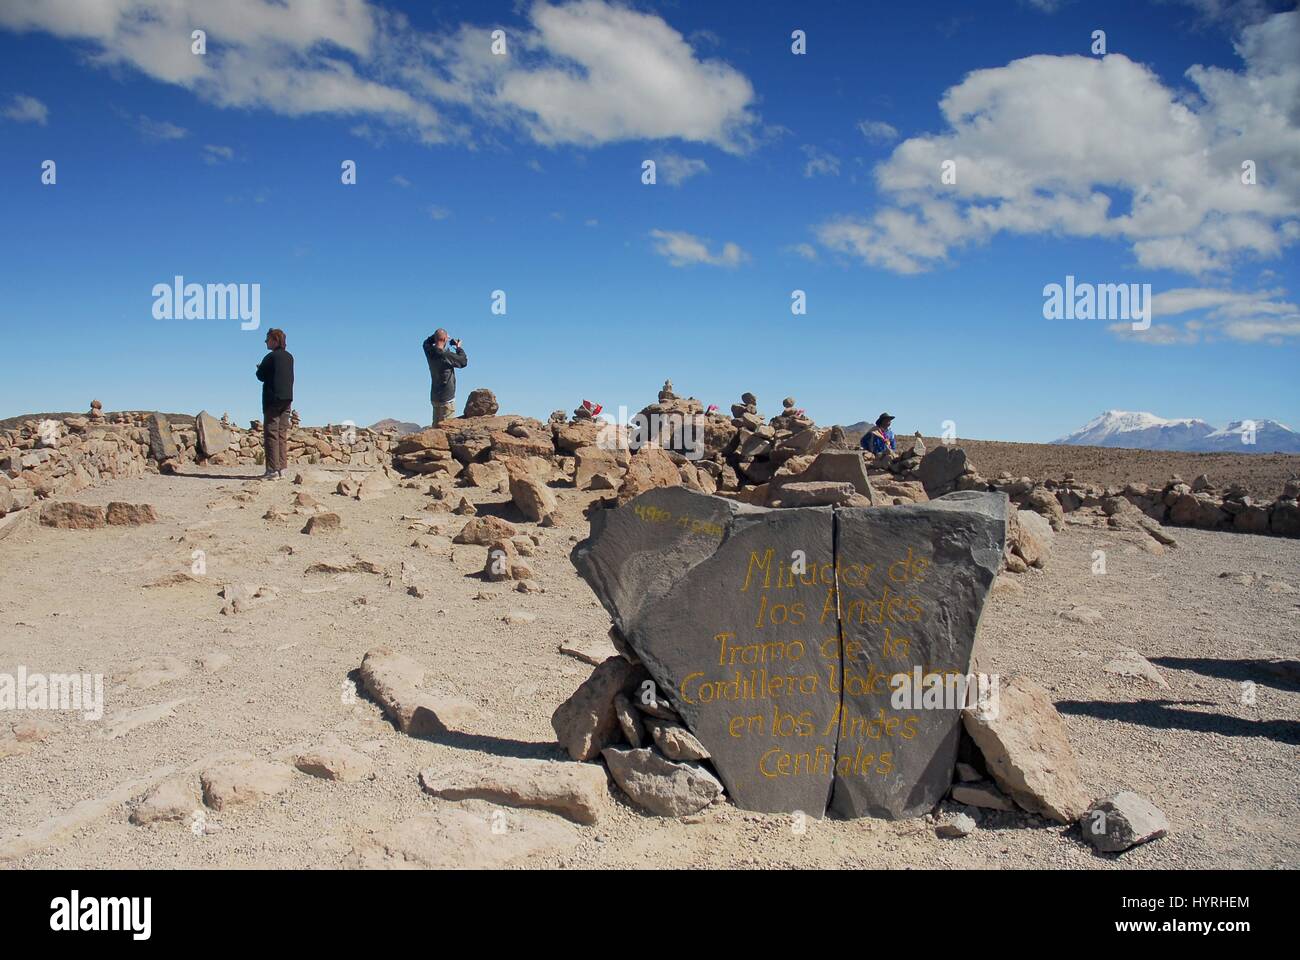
0;0;758;152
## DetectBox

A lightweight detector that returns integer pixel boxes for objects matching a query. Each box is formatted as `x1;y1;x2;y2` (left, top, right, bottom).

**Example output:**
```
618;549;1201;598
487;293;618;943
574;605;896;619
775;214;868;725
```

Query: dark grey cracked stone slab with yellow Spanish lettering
573;486;1006;817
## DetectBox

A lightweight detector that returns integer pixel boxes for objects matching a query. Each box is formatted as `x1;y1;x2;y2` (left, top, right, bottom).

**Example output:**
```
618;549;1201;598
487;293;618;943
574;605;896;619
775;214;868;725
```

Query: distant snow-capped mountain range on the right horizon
1052;410;1300;453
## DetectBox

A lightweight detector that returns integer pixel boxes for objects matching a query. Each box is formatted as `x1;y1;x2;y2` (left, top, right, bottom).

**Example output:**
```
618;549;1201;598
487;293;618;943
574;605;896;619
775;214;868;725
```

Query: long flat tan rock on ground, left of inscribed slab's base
420;757;610;823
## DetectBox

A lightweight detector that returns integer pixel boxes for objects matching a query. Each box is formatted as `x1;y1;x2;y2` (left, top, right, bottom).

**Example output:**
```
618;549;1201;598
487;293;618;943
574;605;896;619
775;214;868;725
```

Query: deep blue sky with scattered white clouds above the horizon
0;0;1300;441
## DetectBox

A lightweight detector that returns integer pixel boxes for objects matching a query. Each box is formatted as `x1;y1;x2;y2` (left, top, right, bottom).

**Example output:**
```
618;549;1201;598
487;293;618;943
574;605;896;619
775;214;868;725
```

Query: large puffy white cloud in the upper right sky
814;12;1300;274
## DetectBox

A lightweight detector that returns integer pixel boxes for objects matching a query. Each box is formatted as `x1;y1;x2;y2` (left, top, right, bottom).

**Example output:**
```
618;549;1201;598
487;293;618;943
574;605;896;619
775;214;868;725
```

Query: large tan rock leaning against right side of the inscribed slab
963;676;1088;823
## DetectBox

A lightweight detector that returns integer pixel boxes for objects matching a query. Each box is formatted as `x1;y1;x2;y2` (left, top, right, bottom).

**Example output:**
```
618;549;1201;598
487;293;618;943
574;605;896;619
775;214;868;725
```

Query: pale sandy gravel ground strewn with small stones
0;445;1300;870
